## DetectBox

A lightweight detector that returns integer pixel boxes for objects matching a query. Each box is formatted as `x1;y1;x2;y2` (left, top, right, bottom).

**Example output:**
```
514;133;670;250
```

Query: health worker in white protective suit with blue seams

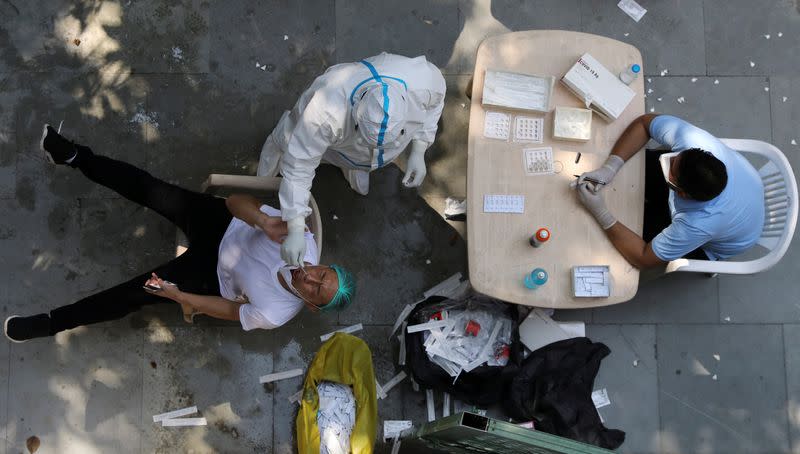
258;52;445;266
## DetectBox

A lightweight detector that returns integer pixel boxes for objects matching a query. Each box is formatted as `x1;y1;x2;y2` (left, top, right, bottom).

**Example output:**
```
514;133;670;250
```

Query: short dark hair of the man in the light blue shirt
676;148;728;202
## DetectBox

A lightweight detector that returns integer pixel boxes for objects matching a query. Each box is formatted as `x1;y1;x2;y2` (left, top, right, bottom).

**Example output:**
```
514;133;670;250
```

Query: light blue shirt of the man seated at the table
647;115;764;261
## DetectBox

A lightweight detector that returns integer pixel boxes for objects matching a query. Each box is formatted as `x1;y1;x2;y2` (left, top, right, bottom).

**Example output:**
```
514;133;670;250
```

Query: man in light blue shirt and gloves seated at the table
577;114;764;268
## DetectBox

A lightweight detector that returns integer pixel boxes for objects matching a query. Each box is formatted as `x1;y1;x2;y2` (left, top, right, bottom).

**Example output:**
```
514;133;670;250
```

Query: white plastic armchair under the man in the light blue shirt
666;139;798;274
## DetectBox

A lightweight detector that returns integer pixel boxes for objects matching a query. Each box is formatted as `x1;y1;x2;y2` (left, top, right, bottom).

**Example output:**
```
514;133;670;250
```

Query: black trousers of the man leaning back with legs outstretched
50;149;232;334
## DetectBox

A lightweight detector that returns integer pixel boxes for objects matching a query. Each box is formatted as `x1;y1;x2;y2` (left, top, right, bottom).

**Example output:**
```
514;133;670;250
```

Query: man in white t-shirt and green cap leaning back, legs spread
4;126;355;342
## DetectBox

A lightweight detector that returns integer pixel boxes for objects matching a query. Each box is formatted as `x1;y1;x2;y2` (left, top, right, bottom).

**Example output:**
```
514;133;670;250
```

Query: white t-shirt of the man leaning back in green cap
217;205;319;331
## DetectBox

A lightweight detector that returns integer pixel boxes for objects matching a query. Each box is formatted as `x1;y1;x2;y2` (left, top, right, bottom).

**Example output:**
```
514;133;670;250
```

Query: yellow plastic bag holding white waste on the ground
297;333;378;454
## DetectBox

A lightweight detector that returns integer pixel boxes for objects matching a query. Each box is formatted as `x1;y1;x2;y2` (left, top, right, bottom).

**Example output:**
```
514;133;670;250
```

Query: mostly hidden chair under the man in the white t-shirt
175;173;322;260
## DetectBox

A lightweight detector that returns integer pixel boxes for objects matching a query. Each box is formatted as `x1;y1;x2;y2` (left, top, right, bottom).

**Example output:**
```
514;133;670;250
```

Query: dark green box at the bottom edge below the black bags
416;412;614;454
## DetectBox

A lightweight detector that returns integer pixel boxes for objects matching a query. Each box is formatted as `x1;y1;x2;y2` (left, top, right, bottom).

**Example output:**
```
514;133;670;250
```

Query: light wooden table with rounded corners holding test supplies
467;30;644;309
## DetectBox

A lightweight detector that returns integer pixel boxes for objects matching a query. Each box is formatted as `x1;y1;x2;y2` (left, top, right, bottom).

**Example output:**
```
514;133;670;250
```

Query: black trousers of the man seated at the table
642;150;708;260
